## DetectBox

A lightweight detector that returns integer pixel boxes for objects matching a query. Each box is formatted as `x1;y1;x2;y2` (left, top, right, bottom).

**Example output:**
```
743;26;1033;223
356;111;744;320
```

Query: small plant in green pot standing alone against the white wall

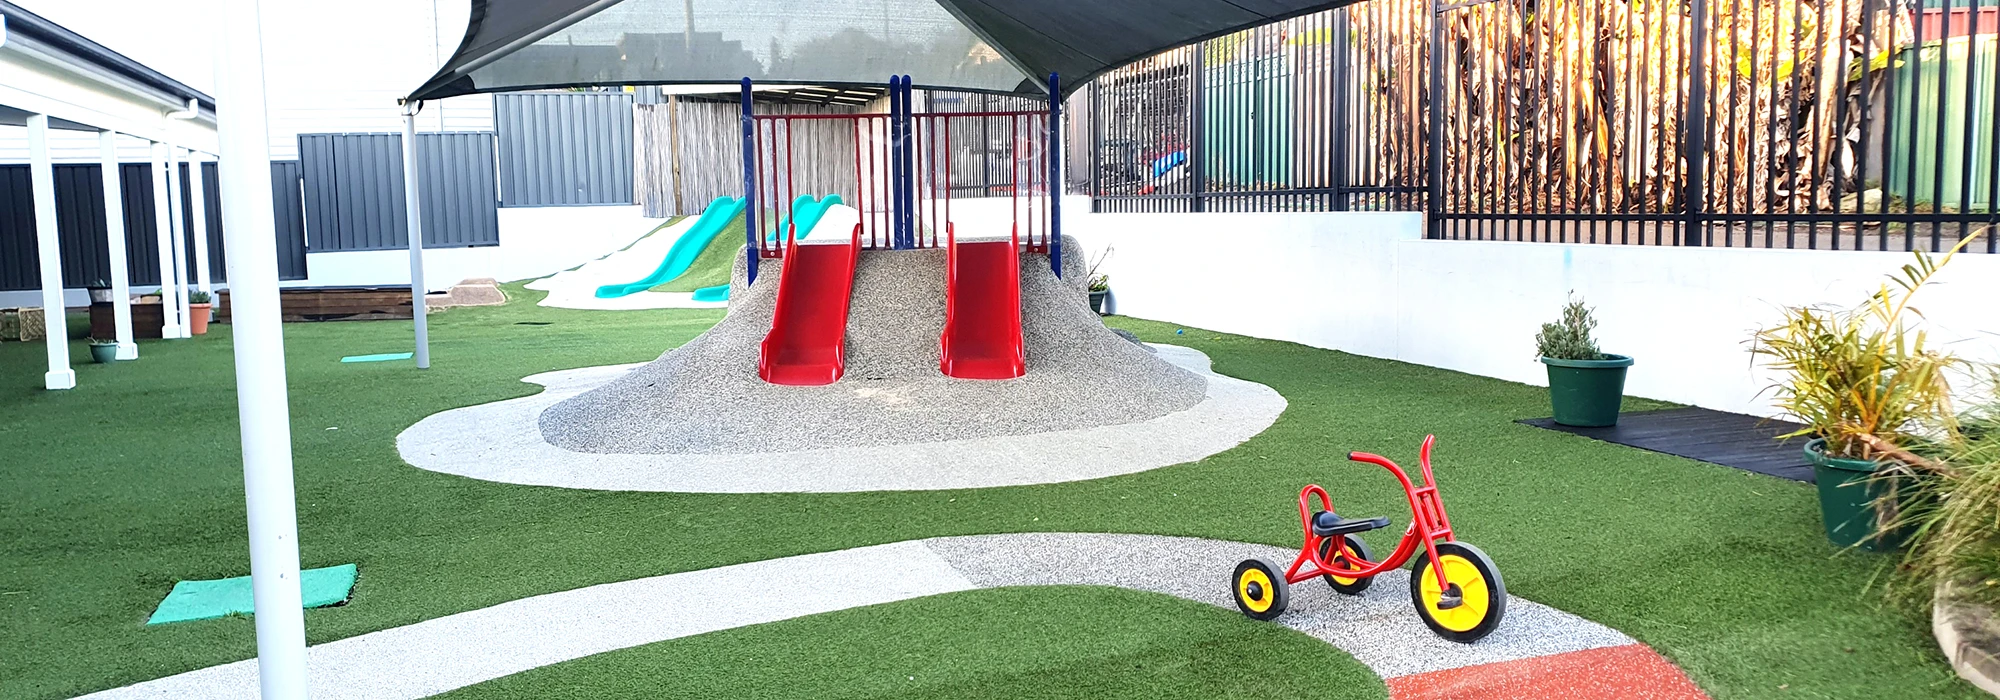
1534;296;1632;428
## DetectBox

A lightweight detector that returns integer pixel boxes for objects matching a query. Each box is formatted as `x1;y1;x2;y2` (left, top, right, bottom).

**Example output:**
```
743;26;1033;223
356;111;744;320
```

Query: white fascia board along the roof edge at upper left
0;36;218;154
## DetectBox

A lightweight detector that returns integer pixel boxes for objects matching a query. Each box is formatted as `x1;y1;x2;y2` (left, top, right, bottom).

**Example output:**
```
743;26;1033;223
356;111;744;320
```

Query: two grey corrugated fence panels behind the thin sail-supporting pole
298;132;500;252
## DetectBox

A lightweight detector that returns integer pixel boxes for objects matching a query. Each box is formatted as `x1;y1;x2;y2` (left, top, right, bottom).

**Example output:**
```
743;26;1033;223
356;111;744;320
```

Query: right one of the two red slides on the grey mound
938;228;1028;380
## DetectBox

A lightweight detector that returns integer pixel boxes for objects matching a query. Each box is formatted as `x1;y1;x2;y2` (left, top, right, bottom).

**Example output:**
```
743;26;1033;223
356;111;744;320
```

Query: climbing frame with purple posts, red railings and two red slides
742;76;1062;384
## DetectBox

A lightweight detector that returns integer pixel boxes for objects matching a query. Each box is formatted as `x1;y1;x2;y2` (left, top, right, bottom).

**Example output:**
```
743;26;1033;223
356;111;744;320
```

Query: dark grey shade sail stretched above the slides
410;0;1354;100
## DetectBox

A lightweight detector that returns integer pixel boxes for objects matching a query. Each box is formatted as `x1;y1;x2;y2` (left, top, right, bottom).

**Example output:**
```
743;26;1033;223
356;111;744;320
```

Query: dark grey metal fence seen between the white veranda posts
0;162;306;292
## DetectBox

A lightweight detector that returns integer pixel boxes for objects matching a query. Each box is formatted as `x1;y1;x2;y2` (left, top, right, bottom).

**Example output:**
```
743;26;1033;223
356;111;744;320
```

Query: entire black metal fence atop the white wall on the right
1090;0;2000;252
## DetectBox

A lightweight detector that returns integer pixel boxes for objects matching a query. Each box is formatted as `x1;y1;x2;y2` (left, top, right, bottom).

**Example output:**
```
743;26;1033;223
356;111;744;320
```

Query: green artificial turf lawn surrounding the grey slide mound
0;286;1978;698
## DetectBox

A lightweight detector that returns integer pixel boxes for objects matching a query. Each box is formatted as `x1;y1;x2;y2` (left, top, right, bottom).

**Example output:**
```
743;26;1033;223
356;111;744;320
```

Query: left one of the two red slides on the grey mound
756;226;862;386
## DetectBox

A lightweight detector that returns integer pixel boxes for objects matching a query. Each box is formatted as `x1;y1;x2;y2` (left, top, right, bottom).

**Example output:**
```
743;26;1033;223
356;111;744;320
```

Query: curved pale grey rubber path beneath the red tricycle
88;532;1632;700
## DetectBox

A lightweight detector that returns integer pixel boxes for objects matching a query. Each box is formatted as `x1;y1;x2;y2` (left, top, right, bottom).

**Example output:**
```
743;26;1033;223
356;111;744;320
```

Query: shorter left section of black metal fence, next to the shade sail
1088;0;1428;212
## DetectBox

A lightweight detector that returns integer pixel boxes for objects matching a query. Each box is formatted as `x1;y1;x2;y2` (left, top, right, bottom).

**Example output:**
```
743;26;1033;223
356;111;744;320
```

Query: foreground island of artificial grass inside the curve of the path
444;588;1388;700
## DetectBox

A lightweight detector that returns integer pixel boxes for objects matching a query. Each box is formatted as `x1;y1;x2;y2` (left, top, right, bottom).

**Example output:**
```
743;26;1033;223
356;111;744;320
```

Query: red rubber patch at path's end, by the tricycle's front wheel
1388;644;1708;700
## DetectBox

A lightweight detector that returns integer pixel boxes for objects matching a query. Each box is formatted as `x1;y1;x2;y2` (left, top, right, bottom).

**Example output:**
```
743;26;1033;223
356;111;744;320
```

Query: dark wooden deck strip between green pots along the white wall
1520;408;1812;484
